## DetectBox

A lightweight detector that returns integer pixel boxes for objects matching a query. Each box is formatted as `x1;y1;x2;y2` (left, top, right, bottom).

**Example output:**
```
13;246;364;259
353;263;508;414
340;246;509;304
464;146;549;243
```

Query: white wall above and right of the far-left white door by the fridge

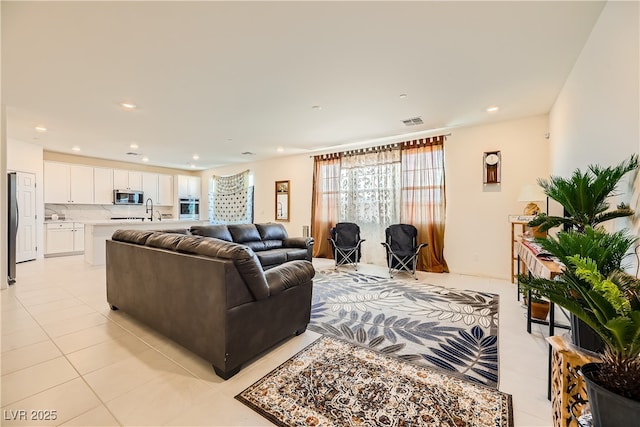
7;139;44;258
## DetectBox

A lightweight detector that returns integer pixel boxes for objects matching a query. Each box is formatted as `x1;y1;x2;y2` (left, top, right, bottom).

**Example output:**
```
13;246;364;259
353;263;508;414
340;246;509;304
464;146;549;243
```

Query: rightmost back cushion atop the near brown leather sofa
176;236;269;300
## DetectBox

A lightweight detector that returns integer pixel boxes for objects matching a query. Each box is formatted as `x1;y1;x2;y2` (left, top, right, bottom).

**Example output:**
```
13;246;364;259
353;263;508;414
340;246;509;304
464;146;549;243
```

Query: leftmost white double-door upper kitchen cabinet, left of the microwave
44;162;94;205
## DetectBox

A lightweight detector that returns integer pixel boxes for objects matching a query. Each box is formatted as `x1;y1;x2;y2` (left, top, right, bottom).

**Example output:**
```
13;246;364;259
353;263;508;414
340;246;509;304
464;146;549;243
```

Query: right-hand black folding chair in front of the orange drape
382;224;427;280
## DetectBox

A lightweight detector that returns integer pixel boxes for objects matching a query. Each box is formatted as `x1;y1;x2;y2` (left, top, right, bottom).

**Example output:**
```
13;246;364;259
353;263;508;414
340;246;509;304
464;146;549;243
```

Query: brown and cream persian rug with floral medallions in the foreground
236;336;513;427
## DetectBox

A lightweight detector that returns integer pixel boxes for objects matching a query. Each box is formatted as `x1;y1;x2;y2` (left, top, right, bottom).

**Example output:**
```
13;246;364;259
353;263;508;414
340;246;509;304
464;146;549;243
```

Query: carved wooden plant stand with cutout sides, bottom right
547;336;600;427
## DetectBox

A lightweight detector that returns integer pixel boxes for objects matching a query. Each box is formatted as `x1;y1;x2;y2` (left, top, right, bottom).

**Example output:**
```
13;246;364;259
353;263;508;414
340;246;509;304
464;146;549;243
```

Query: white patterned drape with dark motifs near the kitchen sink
209;170;253;224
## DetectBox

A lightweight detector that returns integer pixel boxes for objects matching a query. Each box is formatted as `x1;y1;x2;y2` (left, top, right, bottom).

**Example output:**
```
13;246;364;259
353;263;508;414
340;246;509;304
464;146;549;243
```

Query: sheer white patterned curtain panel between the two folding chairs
339;147;402;265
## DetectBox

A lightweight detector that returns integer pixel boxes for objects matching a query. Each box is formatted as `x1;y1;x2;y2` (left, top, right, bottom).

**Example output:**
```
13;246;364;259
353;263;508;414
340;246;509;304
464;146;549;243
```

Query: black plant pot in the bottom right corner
580;363;640;427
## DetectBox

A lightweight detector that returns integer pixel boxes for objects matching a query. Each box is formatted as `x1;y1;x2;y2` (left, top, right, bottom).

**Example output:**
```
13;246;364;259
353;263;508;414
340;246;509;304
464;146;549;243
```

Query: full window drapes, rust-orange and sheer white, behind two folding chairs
311;136;449;272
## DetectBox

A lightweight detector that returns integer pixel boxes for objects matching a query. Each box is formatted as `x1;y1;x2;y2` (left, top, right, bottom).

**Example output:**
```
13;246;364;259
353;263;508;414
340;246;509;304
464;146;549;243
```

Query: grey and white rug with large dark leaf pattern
308;270;498;388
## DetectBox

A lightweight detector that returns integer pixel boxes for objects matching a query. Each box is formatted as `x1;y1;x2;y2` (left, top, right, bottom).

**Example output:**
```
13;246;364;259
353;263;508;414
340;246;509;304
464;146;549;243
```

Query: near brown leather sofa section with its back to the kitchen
106;230;315;379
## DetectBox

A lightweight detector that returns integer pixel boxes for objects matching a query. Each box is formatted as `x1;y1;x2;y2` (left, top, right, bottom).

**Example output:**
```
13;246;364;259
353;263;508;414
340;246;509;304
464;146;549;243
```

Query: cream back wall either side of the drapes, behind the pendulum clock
202;115;548;279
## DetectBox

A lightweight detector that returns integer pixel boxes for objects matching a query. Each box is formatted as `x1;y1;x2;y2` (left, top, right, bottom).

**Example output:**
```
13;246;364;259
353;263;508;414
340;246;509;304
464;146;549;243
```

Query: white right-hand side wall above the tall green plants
550;1;640;176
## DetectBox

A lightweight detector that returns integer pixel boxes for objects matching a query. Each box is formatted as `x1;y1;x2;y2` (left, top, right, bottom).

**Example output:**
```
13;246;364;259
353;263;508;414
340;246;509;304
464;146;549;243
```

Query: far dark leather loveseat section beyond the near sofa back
190;223;314;270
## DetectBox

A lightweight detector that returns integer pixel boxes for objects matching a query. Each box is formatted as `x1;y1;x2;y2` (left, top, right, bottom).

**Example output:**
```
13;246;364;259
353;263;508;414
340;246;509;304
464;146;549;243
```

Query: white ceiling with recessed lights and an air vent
1;1;603;169
